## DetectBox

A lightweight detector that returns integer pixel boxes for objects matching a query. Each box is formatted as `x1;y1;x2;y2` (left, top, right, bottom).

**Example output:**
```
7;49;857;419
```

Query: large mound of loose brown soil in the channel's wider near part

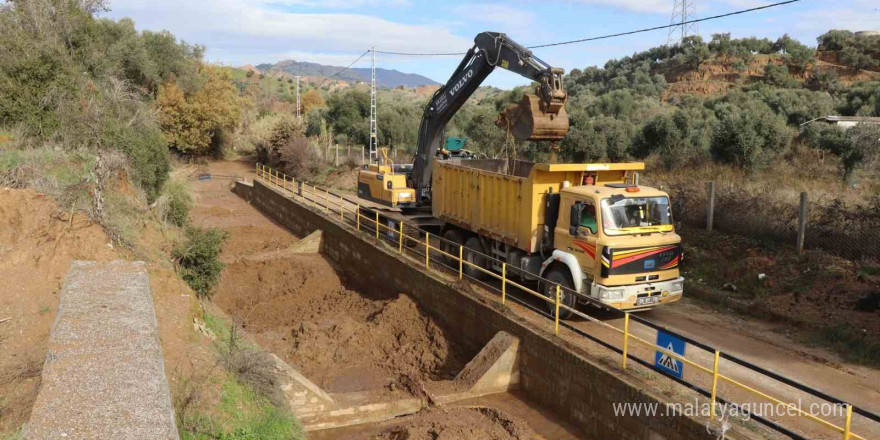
214;254;467;393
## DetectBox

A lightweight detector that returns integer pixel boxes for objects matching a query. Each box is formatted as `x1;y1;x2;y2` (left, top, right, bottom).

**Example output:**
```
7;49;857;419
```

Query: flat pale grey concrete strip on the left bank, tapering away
26;261;178;440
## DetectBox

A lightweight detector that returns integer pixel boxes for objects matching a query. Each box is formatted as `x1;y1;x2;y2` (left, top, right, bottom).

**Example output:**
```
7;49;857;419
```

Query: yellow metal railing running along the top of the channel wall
256;164;880;440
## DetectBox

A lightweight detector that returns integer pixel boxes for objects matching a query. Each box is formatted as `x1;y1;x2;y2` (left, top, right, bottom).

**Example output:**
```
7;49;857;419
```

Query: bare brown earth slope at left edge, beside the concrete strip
0;188;119;433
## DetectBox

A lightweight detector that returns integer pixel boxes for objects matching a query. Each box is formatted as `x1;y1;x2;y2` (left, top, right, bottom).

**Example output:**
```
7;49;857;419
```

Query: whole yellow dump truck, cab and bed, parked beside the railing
431;159;684;317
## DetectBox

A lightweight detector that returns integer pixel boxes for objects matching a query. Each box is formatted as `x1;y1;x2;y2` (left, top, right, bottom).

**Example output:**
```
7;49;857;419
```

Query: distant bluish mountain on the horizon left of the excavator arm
256;60;439;88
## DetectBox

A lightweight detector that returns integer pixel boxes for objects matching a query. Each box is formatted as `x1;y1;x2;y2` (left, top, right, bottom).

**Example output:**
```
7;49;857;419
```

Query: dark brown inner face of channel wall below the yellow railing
235;181;716;440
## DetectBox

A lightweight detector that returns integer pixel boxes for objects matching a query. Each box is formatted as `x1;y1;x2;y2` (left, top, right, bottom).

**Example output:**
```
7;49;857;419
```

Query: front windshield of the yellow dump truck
602;196;672;235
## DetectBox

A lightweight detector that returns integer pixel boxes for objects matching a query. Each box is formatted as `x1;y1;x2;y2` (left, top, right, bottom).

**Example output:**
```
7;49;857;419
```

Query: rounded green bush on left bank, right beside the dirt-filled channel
172;226;229;297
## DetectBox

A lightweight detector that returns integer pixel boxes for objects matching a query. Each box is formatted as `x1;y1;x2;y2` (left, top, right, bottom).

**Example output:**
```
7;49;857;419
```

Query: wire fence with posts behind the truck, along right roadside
666;182;880;261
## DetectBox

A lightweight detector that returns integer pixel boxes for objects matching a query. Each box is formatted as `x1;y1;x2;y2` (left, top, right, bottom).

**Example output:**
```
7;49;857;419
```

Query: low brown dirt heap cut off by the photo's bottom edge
372;408;537;440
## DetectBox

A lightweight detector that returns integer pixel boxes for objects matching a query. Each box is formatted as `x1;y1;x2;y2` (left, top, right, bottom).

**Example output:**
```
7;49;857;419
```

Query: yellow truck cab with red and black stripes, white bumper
544;184;684;310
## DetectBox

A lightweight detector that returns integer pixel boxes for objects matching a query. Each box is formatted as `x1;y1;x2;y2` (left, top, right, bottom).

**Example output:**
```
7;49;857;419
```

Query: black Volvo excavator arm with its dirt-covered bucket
411;32;568;205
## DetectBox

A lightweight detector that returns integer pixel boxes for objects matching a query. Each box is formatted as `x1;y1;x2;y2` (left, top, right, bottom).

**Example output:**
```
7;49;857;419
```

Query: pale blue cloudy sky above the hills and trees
108;0;880;88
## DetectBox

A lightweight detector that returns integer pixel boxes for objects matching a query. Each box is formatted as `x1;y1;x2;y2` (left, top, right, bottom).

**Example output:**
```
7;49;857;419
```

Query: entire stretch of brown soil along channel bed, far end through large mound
192;162;469;394
